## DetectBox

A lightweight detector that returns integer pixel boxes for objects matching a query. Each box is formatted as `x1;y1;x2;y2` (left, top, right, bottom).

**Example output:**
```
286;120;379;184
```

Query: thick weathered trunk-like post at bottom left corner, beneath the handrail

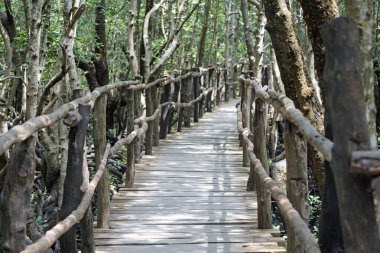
0;136;36;253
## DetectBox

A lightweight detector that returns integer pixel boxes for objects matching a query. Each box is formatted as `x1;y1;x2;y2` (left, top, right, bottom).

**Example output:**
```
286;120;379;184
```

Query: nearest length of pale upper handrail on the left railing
0;81;140;155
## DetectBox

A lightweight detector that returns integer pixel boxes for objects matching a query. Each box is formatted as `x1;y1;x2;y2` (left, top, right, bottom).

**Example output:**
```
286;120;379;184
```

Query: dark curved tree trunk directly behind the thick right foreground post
299;0;343;253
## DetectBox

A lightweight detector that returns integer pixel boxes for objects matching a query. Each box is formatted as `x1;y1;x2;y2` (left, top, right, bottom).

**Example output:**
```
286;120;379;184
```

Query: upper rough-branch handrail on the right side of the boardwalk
240;77;333;162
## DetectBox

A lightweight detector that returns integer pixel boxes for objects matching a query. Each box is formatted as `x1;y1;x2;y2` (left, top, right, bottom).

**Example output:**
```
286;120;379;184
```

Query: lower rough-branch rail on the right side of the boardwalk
237;109;321;253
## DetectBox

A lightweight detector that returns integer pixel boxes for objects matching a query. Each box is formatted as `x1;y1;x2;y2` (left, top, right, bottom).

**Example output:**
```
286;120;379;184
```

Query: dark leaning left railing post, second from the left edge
59;92;91;253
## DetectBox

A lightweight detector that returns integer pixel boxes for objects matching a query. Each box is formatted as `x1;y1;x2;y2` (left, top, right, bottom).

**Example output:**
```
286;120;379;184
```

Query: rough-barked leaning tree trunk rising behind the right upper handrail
263;0;324;195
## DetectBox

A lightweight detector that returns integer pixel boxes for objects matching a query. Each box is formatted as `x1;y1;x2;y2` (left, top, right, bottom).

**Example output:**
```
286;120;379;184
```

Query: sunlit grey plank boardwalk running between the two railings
95;101;286;253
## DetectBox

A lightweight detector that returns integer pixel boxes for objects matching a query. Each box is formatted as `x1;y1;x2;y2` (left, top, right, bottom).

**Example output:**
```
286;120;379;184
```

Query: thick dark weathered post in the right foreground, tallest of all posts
322;18;380;253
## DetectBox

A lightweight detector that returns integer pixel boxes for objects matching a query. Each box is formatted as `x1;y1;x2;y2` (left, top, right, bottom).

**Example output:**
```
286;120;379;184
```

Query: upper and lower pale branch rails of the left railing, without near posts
0;67;228;252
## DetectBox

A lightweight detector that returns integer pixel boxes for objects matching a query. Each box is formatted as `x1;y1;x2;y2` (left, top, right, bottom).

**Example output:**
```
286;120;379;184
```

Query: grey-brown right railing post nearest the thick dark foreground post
284;120;309;253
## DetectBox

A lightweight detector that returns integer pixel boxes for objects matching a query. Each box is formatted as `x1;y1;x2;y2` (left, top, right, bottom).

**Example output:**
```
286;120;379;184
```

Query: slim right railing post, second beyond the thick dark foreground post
250;89;272;229
